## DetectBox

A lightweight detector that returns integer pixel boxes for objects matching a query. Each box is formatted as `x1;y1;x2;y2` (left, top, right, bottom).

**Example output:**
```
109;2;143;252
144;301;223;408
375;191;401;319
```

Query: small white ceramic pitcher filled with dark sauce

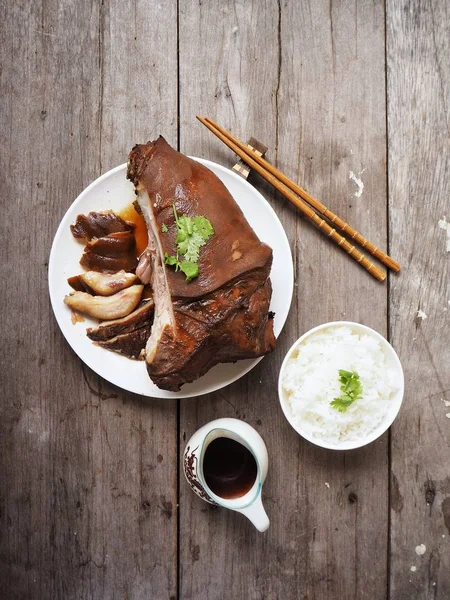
183;418;270;531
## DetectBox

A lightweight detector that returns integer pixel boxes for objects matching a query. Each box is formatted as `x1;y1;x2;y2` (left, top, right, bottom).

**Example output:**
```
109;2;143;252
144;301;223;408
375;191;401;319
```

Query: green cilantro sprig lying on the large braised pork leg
161;204;214;282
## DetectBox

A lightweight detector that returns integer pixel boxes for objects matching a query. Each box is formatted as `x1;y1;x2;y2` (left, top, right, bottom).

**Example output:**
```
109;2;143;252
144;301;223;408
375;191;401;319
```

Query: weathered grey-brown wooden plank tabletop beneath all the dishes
0;0;450;600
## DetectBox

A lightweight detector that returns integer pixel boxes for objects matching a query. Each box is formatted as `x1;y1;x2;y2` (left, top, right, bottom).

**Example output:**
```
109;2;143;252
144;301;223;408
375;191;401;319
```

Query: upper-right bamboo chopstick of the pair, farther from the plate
205;117;400;272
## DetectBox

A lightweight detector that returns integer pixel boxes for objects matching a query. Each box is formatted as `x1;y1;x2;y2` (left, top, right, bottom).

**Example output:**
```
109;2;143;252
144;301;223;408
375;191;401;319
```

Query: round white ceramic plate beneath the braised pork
48;158;294;398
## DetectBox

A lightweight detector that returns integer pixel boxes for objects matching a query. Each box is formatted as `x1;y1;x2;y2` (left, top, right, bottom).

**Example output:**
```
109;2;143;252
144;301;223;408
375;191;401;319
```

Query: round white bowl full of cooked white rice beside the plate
279;322;404;449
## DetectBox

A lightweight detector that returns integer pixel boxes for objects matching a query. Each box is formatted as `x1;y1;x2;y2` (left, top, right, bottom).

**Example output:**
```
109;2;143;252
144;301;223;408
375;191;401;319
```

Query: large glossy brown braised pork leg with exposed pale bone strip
127;137;276;391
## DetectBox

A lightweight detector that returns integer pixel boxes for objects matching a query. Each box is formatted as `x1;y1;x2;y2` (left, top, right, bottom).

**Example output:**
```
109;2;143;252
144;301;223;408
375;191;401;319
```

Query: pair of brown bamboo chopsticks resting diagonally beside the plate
197;116;400;281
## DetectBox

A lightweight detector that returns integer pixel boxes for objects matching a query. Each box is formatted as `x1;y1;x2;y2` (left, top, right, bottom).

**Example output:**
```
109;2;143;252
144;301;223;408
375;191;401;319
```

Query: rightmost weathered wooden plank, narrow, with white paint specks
387;0;450;600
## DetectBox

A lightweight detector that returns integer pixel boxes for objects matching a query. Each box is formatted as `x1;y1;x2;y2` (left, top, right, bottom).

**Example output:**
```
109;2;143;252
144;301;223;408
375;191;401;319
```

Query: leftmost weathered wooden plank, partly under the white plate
0;0;177;600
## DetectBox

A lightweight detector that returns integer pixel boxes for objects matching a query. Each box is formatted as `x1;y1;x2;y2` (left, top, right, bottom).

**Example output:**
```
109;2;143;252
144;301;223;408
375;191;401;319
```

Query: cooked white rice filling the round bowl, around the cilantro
282;325;397;444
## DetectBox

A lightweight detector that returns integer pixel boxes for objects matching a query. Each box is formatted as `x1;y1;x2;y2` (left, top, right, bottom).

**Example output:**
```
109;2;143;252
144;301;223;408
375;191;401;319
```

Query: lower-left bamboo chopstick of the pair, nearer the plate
197;116;386;281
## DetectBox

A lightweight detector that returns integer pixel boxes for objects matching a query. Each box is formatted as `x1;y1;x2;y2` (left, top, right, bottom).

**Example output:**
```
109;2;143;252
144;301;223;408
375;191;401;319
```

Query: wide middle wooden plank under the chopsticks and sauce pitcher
180;0;388;600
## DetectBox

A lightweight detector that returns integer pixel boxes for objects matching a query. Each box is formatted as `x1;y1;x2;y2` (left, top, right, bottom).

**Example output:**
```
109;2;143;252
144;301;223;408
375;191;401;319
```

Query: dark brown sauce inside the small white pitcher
203;437;258;499
